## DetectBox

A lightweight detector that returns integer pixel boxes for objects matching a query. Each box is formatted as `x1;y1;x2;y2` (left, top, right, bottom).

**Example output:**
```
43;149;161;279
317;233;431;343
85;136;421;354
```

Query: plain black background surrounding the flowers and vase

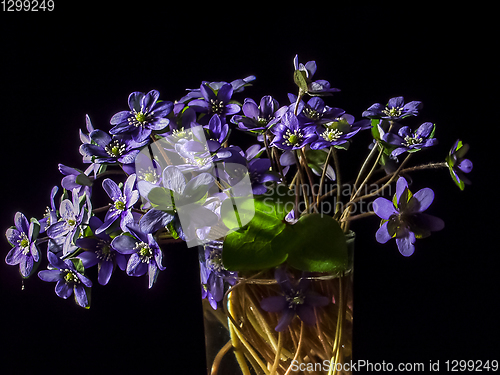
0;0;499;375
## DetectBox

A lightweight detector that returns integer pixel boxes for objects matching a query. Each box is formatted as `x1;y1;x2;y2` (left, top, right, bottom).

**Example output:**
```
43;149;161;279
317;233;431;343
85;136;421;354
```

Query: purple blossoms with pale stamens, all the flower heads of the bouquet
6;57;472;320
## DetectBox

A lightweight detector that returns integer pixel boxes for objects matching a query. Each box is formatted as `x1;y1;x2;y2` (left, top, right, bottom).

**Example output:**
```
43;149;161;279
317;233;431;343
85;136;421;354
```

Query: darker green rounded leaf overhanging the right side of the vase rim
279;213;348;272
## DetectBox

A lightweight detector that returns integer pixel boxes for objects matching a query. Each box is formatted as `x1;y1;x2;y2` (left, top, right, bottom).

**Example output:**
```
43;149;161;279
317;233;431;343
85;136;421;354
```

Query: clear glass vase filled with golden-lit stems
200;232;355;375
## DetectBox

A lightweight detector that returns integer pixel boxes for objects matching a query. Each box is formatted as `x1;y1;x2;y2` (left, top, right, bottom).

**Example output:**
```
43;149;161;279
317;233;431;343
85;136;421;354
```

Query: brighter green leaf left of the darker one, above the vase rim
222;195;293;271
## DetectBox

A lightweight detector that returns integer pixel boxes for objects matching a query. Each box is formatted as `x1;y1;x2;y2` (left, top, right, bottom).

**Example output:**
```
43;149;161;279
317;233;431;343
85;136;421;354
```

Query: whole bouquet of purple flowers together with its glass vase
5;56;472;374
